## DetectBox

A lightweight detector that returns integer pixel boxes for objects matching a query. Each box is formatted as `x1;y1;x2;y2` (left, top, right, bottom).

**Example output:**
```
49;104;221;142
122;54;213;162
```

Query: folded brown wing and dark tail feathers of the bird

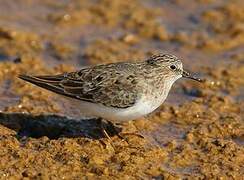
19;65;138;108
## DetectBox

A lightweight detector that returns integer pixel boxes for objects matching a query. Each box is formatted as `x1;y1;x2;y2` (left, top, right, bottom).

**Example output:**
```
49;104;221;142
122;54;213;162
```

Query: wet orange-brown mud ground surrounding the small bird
0;0;244;179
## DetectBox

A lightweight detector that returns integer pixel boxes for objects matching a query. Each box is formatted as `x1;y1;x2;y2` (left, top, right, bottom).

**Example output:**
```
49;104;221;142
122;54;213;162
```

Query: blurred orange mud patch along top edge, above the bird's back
47;0;169;41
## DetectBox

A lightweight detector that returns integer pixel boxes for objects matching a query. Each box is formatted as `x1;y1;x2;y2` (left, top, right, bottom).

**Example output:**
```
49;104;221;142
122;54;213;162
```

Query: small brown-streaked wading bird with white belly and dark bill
19;54;201;138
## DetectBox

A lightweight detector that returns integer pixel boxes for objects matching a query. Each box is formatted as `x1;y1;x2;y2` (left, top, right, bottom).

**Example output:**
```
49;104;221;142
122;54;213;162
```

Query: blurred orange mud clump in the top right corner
202;1;244;51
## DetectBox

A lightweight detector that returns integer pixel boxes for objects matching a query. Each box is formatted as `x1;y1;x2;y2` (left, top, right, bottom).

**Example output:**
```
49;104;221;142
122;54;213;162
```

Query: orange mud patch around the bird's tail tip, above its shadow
0;57;72;114
